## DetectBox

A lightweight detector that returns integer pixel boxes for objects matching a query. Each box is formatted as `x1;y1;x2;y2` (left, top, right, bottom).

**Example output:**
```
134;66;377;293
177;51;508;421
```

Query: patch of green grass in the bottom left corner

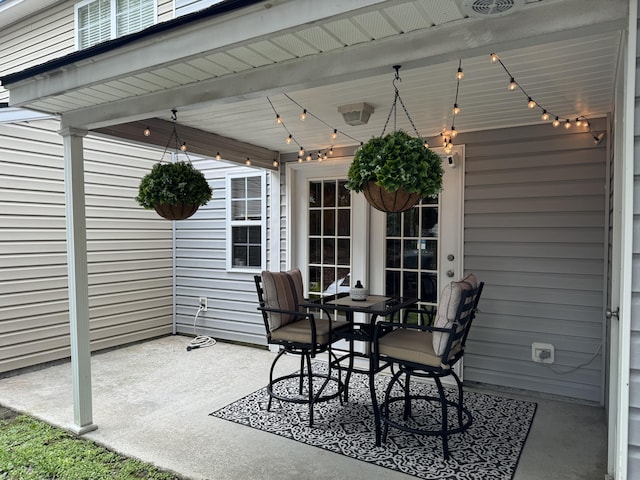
0;414;182;480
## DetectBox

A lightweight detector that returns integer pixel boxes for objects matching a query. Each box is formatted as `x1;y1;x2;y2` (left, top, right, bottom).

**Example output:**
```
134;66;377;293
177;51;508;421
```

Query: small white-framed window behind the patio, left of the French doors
226;172;267;272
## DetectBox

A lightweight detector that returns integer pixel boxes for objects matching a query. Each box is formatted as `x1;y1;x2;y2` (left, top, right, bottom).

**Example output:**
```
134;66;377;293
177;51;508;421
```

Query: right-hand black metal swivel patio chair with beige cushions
373;274;484;460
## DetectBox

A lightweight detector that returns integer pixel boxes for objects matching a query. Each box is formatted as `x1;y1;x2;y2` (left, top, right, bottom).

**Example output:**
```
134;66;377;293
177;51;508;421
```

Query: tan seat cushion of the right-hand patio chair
378;328;449;368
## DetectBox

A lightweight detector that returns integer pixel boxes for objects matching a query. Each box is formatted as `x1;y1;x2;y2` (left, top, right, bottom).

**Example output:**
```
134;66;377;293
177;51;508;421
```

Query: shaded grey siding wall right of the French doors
458;119;606;402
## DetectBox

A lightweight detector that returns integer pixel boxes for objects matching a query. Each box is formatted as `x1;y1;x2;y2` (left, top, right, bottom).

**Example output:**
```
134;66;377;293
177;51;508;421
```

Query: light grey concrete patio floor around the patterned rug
0;336;607;480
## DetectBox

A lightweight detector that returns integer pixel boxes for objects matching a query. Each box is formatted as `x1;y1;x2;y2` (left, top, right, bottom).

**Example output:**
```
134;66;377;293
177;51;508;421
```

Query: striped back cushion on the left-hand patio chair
262;268;304;332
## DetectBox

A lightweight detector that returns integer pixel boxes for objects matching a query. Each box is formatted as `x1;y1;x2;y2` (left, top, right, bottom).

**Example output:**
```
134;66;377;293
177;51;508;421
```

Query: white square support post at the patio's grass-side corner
59;128;98;435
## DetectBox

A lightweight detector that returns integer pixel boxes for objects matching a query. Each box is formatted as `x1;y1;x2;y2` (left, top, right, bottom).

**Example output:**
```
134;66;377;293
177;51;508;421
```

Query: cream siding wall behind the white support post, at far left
0;120;173;372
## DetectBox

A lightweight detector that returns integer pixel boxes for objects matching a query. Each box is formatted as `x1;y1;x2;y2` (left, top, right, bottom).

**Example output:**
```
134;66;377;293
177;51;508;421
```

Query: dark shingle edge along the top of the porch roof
0;0;265;87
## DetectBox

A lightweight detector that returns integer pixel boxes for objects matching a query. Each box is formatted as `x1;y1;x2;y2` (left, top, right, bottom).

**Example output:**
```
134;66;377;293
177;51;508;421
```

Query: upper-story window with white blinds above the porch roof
75;0;158;50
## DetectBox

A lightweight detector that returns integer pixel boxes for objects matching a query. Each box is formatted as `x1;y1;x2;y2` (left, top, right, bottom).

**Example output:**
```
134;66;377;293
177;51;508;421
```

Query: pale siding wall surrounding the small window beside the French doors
176;160;272;345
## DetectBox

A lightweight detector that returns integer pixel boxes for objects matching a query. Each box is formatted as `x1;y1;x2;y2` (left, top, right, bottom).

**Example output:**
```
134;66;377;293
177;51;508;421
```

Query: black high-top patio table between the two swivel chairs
300;293;418;445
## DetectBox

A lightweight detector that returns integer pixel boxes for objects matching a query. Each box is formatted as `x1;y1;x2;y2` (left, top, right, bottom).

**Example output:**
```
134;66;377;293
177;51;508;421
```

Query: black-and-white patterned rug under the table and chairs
210;366;536;480
